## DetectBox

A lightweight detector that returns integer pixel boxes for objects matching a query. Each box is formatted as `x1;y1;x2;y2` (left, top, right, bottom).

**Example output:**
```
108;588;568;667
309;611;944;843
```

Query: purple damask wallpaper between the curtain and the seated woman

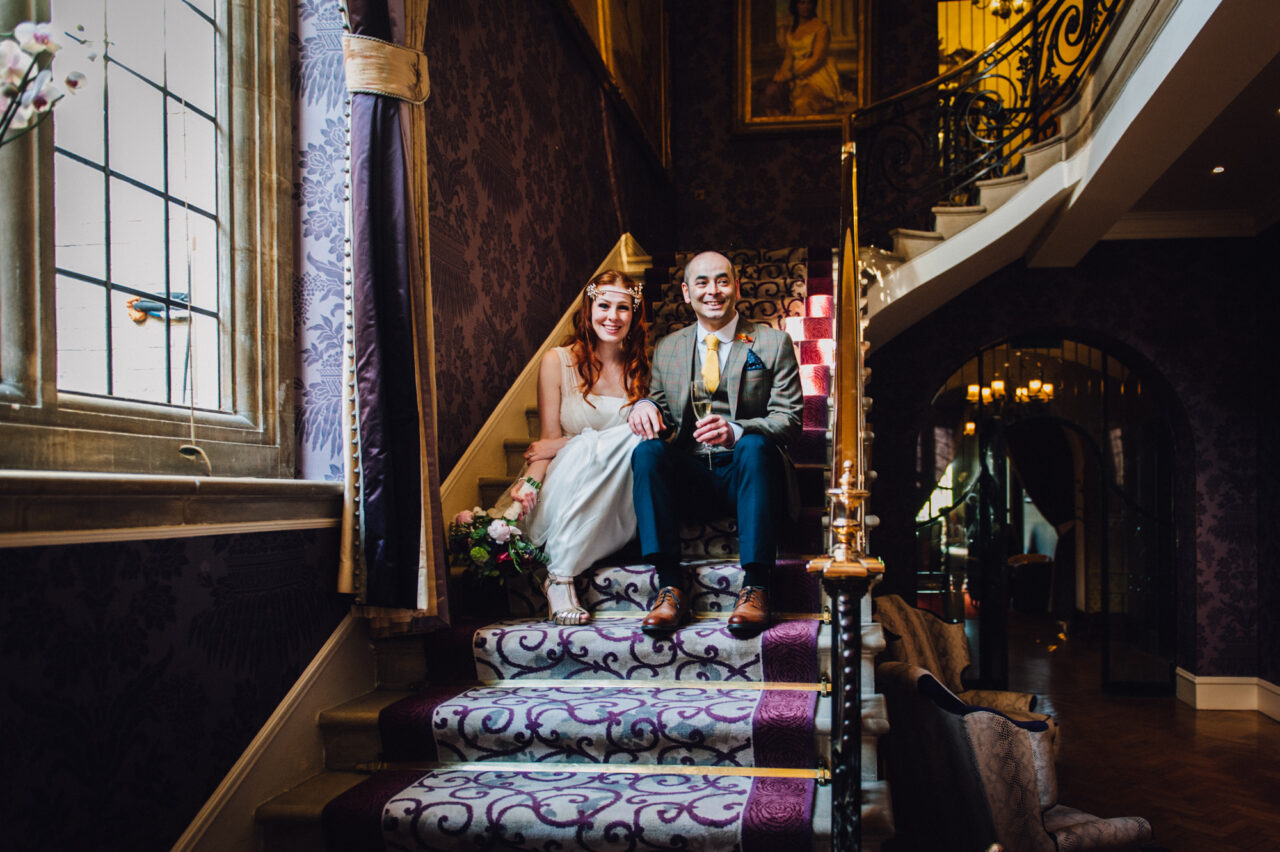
426;0;671;471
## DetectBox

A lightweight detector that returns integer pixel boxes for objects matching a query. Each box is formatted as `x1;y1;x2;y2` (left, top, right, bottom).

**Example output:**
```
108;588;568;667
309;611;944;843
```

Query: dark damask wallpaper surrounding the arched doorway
868;233;1280;682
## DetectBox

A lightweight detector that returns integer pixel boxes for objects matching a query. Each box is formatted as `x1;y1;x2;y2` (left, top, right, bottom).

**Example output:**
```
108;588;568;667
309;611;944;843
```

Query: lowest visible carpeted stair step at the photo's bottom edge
312;766;831;852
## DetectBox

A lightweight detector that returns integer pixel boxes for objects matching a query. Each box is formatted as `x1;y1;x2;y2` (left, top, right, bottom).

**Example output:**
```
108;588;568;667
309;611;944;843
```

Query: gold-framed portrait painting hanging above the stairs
735;0;869;130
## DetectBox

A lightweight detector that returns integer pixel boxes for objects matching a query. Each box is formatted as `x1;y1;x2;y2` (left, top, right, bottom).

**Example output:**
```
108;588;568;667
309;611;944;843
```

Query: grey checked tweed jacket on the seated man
649;316;804;448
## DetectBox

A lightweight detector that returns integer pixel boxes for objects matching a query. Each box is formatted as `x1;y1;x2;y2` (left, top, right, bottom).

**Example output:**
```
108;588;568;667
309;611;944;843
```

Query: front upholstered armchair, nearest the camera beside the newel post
876;663;1151;852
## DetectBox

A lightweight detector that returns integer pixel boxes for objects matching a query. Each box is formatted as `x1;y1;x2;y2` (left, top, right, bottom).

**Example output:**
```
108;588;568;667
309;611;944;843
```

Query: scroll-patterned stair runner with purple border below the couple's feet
324;560;829;849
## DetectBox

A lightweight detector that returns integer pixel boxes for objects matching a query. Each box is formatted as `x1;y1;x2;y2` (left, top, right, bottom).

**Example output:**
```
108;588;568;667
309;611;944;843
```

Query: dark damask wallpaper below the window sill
0;530;347;852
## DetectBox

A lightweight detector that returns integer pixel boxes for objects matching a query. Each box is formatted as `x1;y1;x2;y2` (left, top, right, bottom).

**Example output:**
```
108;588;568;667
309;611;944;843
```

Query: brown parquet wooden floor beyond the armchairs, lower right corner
1009;613;1280;852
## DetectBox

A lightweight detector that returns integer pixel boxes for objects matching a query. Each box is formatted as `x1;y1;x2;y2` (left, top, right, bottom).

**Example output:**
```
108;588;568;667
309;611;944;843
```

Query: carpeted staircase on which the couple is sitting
249;249;887;852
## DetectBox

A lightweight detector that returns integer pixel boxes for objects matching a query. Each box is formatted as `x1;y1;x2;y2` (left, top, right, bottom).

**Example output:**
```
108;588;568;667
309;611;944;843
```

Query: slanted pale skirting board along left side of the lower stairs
172;615;375;852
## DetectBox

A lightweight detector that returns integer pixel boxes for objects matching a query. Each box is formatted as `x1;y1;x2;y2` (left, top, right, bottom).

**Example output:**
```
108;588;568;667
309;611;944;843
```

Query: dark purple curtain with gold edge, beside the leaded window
347;0;447;621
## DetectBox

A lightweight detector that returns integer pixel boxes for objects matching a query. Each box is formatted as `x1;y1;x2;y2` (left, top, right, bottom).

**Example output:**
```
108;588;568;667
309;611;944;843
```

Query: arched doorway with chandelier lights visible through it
916;336;1178;692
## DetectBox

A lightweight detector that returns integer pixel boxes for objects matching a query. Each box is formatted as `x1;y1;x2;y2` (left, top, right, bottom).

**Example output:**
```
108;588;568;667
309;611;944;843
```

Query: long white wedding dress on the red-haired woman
525;347;640;577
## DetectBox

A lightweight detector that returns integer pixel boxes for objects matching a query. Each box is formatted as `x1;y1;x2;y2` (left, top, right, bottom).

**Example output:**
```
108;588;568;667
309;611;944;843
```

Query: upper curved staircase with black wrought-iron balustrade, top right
849;0;1280;348
